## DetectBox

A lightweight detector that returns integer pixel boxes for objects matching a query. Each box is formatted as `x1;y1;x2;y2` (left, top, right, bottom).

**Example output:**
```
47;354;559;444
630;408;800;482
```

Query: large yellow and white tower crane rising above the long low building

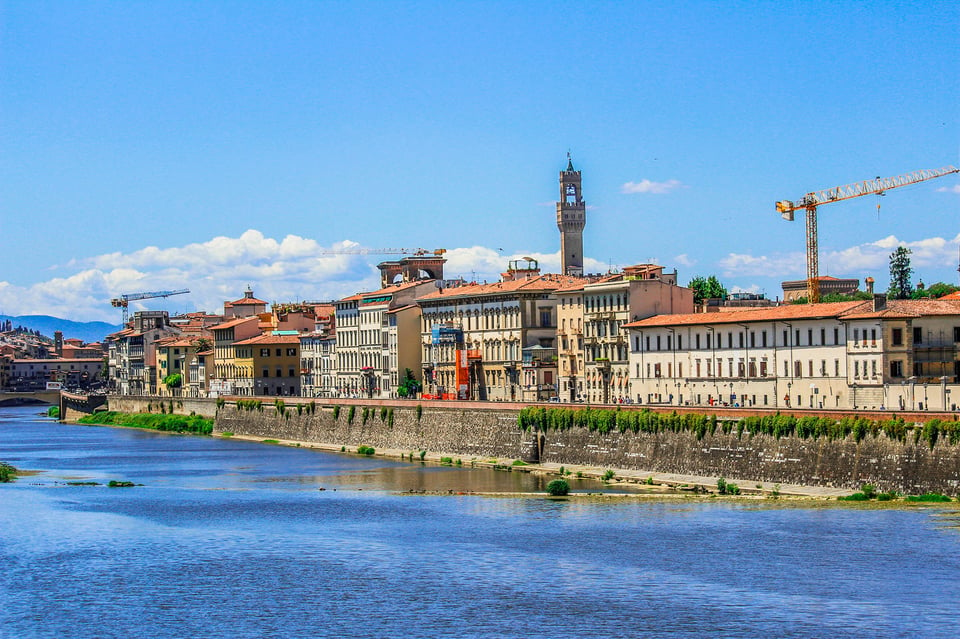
777;166;960;303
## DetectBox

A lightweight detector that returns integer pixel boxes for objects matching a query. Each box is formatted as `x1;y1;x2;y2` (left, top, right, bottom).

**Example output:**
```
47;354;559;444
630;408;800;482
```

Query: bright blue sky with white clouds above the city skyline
0;1;960;321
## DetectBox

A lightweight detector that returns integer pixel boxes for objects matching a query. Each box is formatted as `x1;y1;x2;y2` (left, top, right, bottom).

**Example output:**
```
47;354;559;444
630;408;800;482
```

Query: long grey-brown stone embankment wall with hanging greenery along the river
103;397;960;495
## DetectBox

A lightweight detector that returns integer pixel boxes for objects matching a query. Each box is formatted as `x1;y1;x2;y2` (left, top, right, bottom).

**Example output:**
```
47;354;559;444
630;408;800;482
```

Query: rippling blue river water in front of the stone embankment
0;408;960;639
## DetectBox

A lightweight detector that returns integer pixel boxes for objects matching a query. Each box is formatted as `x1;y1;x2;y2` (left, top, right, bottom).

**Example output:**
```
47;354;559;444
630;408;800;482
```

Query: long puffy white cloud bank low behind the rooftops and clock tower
0;230;608;323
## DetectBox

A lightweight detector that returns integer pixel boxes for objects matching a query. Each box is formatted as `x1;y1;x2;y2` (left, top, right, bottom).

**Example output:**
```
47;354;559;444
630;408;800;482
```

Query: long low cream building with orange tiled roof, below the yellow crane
625;295;960;410
